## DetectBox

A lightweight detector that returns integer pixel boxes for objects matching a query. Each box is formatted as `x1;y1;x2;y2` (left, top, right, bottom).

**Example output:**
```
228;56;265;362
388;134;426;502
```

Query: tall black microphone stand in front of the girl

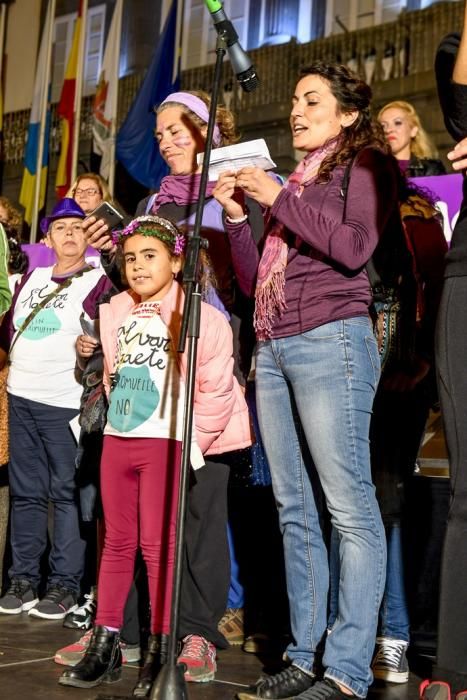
96;34;227;700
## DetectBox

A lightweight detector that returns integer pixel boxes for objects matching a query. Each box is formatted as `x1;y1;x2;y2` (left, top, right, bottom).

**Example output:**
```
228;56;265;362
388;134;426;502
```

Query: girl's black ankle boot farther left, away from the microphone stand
58;626;122;688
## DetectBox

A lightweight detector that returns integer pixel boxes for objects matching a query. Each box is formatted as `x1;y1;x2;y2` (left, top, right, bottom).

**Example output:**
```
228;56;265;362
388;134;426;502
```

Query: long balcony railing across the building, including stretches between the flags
3;2;463;163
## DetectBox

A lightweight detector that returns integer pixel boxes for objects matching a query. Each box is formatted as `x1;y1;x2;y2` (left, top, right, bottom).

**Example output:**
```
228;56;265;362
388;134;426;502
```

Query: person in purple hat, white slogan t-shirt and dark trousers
0;198;110;620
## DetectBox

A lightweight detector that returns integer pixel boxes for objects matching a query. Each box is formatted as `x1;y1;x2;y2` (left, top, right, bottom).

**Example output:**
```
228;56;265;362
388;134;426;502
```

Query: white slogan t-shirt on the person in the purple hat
7;267;102;409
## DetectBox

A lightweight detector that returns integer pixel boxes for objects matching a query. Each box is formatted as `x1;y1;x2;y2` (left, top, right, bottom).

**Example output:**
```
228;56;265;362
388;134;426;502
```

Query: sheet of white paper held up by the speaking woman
198;139;276;181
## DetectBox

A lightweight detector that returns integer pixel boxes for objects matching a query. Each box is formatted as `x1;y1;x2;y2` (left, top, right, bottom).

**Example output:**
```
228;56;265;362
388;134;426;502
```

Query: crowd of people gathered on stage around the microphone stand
0;9;467;700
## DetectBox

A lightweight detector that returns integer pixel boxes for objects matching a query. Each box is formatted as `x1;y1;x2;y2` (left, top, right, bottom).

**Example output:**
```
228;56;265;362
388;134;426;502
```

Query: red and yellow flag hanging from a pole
55;0;83;199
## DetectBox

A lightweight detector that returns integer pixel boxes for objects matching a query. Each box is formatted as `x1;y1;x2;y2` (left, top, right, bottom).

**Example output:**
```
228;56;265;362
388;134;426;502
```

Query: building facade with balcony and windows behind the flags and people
3;0;463;213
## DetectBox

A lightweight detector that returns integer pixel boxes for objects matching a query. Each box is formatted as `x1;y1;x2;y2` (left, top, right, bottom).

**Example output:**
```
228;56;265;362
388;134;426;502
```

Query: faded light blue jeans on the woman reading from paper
256;317;386;697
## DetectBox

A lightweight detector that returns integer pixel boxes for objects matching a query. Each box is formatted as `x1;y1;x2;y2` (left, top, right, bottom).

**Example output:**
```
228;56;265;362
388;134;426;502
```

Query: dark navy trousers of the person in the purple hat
8;394;85;592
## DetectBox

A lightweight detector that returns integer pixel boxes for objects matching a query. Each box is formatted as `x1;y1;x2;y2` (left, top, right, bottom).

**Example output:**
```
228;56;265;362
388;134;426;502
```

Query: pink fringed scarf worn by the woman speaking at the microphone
254;137;339;340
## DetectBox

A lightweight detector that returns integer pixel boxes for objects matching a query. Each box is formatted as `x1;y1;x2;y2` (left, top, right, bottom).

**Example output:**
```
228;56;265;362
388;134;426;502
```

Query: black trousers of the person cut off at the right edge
436;277;467;692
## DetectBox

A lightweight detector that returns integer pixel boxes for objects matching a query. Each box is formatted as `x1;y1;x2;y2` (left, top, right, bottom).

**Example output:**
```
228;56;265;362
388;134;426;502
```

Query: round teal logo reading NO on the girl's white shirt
107;365;160;433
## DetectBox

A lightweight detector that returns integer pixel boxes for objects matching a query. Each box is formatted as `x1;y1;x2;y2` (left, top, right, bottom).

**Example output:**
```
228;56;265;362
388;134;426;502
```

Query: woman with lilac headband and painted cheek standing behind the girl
82;87;263;682
